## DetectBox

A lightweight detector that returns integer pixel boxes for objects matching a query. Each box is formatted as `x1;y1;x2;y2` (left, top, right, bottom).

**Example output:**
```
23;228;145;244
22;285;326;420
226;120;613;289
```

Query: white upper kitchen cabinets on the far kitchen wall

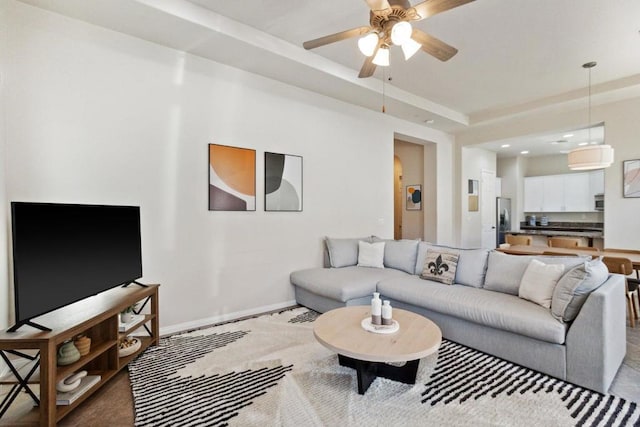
524;170;604;213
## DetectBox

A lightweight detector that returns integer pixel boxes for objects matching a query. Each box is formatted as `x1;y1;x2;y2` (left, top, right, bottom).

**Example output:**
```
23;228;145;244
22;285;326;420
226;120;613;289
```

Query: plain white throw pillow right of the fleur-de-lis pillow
518;259;564;309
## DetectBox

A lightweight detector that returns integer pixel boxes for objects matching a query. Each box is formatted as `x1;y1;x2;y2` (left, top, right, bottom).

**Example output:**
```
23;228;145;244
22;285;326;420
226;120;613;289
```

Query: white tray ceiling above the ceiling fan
15;0;640;154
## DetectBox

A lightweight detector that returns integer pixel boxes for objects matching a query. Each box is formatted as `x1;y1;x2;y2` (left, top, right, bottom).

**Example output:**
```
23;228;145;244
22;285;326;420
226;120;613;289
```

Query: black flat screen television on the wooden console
9;202;142;331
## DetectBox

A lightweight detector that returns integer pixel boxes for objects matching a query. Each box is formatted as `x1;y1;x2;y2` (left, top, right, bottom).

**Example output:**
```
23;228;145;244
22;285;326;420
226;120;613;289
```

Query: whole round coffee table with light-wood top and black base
313;306;442;394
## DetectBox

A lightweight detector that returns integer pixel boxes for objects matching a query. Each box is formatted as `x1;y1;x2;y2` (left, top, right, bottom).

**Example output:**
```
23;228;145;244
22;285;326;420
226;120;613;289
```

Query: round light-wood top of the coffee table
313;306;442;362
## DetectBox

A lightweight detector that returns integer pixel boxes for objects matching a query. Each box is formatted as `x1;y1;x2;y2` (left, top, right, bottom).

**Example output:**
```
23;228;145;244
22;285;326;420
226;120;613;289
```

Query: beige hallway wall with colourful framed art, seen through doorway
394;140;425;239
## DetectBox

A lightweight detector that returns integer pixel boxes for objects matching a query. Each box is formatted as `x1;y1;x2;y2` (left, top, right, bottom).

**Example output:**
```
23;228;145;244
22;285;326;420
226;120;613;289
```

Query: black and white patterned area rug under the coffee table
129;308;640;427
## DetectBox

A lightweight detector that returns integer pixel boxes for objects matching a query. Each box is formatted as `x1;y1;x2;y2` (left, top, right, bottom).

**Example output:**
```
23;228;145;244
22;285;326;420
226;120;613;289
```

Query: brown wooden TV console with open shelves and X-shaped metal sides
0;284;159;426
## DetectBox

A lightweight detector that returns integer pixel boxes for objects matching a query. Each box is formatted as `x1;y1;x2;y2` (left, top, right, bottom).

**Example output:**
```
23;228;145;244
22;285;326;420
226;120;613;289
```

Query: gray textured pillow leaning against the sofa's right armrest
551;259;609;322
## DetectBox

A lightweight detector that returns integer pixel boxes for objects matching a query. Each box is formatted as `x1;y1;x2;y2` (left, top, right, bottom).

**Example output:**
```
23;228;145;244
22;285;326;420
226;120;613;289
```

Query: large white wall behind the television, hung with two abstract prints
0;0;454;330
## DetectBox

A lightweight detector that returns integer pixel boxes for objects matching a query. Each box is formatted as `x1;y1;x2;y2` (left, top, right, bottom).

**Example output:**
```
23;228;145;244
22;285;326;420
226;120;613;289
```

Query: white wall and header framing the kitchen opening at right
456;98;640;248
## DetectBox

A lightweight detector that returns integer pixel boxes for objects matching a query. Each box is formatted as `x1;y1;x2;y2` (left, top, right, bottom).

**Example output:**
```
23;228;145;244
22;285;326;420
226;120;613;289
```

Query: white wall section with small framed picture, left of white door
460;147;496;248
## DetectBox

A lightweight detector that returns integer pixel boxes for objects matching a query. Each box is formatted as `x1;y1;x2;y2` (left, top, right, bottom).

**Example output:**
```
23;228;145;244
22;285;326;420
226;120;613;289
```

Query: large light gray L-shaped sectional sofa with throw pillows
290;237;626;392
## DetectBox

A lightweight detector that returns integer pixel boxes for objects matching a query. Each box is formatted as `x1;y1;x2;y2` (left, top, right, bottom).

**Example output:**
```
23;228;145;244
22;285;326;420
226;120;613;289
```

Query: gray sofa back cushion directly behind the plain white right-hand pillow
484;251;586;295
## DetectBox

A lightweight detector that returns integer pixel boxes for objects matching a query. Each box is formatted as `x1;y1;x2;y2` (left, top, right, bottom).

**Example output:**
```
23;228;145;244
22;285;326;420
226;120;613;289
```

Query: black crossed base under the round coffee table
338;354;420;394
